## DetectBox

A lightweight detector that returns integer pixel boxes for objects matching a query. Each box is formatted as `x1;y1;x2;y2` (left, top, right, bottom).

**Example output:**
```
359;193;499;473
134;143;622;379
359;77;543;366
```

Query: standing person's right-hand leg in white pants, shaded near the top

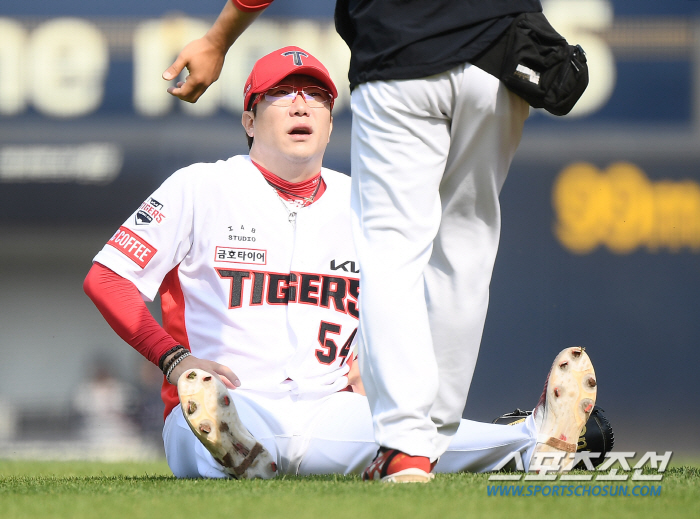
425;64;529;455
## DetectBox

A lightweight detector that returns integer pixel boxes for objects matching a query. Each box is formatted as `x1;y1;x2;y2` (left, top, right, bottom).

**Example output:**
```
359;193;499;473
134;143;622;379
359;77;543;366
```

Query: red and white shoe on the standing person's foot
362;447;435;483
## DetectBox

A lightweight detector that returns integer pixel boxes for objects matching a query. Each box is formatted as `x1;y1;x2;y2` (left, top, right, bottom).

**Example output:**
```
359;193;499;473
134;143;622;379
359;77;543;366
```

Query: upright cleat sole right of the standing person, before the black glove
530;347;598;471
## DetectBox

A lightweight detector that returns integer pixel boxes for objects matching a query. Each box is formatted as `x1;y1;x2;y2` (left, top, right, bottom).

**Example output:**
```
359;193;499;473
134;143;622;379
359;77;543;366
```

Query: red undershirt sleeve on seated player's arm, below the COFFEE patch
83;263;178;366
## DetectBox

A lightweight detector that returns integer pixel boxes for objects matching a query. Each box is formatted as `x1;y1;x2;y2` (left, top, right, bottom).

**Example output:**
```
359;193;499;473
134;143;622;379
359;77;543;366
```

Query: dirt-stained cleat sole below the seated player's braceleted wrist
177;369;277;479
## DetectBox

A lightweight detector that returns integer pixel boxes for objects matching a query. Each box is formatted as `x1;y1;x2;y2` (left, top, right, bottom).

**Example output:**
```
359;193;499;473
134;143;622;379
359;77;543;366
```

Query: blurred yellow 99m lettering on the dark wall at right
552;162;700;254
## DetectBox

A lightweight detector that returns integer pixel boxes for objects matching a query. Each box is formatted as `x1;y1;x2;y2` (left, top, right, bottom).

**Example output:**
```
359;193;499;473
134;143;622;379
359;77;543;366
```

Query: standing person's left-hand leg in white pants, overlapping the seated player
352;74;453;459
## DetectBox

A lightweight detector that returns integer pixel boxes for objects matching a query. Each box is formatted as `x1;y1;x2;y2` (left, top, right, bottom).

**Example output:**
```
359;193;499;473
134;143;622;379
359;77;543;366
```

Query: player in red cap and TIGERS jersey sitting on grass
84;47;596;481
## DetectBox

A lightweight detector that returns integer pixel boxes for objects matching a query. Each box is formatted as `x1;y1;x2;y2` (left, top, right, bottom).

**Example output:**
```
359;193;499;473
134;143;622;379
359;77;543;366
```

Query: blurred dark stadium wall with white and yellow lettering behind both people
0;0;700;459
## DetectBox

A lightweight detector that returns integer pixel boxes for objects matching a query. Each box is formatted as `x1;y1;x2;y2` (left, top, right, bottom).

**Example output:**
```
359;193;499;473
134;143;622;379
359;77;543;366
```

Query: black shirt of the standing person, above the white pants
335;0;542;88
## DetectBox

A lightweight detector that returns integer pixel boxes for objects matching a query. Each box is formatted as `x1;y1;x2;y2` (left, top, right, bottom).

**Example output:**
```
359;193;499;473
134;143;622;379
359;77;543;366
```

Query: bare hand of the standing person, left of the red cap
163;36;226;103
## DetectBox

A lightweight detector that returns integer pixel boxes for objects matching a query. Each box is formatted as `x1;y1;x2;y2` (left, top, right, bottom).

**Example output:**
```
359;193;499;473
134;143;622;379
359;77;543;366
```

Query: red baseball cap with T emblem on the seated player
243;47;338;110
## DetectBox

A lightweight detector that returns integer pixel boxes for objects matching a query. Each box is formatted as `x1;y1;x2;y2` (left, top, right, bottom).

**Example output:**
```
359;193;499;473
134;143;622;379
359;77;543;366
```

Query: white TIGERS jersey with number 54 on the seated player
94;156;359;414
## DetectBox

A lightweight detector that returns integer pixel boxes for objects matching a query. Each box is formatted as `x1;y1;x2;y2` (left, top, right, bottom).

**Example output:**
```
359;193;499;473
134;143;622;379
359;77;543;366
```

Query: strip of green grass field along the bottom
0;461;700;519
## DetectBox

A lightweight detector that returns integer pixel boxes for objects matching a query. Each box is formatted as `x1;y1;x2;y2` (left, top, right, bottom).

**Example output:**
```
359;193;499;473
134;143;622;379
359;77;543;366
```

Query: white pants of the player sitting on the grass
163;389;537;478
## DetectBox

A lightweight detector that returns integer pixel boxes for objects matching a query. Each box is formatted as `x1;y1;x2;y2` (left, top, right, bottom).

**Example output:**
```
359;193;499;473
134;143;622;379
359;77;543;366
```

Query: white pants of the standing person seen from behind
352;64;529;460
